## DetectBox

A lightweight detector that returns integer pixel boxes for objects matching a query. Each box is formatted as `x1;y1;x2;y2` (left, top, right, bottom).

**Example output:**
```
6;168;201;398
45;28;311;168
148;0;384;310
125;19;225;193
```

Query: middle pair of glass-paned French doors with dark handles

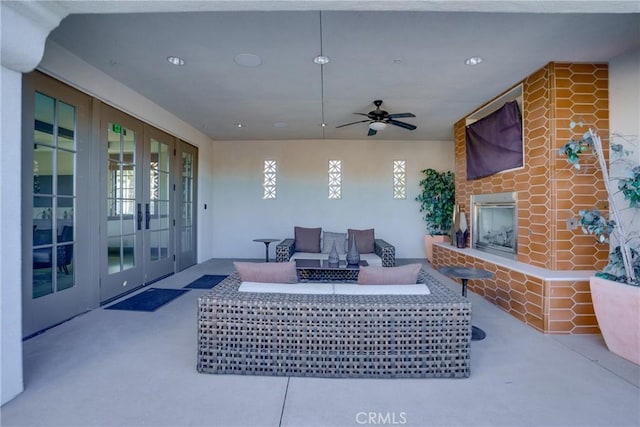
100;106;175;302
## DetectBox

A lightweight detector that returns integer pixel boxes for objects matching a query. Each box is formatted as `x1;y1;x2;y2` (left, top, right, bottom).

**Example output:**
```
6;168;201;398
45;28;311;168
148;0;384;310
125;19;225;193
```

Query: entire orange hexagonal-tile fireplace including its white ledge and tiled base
433;63;609;334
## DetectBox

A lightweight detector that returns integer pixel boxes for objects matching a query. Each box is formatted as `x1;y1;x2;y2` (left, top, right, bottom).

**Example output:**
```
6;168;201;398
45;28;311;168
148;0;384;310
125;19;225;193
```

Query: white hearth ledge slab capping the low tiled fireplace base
435;243;596;281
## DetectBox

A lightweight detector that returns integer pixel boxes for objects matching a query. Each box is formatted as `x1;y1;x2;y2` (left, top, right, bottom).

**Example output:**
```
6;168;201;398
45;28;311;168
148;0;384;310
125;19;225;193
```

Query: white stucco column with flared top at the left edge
0;2;65;404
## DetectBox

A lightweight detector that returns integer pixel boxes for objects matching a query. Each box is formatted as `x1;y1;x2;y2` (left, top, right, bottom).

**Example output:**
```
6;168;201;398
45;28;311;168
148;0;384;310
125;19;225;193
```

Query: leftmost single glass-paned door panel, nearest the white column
21;72;92;336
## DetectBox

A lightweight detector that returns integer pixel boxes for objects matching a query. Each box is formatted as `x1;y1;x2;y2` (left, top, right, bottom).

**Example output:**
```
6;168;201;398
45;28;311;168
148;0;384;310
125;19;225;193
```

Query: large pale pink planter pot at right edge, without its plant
589;277;640;365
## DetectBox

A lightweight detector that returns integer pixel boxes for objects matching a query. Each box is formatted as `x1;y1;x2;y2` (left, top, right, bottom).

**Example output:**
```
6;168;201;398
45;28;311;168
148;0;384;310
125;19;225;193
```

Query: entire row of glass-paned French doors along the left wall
21;71;198;337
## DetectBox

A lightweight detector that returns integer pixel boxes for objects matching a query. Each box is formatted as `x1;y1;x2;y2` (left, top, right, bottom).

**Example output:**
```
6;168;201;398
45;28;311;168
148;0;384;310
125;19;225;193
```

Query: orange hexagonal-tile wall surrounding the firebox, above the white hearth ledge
454;63;609;270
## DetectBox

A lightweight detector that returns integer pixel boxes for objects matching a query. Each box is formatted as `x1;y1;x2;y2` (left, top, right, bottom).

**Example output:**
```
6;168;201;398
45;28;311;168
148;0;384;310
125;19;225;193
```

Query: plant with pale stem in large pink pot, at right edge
559;122;640;365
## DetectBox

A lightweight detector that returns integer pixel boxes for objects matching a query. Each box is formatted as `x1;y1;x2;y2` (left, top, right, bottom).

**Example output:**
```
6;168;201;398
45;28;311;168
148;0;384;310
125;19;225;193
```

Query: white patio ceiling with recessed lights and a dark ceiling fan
50;2;640;140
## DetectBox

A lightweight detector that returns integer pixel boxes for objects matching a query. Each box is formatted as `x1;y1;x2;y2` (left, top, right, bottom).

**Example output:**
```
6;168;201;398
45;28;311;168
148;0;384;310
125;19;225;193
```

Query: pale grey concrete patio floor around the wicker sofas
2;259;640;427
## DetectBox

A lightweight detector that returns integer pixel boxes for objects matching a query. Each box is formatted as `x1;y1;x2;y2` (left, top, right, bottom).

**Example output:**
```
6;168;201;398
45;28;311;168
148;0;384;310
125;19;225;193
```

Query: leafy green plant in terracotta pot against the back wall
416;169;456;262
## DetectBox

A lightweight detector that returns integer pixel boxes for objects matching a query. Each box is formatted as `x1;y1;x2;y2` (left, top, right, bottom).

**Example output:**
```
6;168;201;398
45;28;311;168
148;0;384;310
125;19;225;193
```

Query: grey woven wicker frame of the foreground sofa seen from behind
197;270;471;378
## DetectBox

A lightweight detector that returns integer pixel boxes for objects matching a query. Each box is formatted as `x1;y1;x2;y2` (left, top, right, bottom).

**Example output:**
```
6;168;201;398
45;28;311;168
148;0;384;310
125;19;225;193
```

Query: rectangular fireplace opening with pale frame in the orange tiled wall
471;192;518;259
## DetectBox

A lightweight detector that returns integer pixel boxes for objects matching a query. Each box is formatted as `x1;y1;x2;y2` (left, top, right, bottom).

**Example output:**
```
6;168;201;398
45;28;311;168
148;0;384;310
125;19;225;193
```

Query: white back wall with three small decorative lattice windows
211;138;454;258
